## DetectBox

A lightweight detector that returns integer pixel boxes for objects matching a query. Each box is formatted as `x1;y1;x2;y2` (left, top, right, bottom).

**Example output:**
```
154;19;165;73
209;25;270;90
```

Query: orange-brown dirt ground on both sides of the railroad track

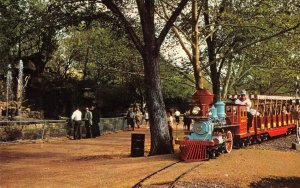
0;128;300;188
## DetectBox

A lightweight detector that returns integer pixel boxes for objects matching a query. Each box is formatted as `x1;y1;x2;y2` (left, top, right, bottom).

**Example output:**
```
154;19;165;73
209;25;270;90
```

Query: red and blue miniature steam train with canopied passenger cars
177;89;299;161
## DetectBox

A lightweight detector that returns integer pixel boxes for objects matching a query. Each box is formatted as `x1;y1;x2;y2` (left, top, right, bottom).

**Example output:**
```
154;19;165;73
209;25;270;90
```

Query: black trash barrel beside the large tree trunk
131;133;145;157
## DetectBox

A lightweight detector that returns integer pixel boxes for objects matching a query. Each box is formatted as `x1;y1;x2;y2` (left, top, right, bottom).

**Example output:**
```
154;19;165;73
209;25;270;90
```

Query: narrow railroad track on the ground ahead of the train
132;161;203;188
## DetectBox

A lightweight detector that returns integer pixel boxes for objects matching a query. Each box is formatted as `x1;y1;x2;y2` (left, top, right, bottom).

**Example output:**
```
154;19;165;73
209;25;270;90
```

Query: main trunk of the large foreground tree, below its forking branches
143;47;173;155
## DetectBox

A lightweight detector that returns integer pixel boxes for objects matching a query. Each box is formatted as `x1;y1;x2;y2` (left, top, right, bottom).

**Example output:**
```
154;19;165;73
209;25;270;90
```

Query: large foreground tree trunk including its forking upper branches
102;0;188;155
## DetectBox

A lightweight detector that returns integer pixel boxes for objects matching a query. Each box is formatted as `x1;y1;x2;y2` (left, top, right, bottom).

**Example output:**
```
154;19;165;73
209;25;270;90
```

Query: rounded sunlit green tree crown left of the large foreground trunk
48;24;142;86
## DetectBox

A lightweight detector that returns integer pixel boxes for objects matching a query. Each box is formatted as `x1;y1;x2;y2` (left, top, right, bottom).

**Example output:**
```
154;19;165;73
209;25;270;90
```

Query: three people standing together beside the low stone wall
71;107;100;140
